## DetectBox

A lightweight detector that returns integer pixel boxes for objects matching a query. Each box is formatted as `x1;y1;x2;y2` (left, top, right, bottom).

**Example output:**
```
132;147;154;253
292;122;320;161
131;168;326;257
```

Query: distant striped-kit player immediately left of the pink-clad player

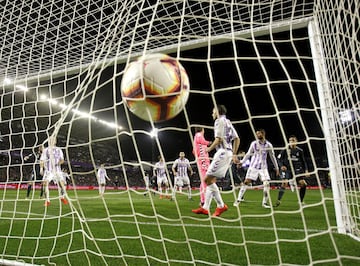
172;151;193;200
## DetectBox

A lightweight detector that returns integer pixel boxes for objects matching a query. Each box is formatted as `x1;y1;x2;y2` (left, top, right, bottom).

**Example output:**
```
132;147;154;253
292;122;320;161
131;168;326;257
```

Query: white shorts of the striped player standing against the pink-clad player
206;149;233;178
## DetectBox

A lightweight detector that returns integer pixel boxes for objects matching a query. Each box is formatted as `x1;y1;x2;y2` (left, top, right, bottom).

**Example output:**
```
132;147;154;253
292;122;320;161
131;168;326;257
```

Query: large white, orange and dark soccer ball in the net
121;54;190;122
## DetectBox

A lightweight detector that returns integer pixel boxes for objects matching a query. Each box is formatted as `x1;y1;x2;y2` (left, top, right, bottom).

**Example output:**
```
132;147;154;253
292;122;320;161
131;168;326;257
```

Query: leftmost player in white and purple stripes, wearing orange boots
40;136;68;207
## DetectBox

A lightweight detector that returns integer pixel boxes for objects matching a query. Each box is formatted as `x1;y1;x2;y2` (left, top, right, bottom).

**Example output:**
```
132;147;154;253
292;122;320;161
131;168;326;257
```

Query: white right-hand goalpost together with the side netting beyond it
309;1;360;240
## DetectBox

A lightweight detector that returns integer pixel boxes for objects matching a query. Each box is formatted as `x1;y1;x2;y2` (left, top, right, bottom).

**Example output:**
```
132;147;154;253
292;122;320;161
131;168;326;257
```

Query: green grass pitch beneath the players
0;190;360;265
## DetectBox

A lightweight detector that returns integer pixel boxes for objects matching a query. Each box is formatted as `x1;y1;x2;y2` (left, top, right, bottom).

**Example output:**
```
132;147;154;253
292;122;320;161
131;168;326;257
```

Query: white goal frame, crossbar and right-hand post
4;16;360;241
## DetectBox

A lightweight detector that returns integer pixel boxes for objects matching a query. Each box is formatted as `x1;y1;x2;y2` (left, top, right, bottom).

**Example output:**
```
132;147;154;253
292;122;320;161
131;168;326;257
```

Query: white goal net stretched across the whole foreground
0;0;360;265
